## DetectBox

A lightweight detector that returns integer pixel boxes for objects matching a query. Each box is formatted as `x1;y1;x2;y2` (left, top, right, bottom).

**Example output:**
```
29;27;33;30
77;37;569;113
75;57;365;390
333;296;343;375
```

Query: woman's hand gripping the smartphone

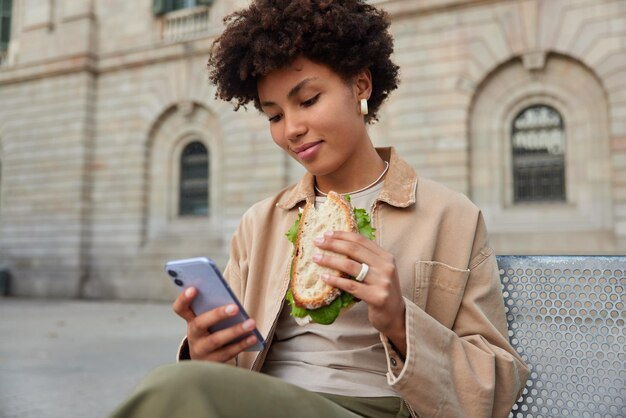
172;287;256;363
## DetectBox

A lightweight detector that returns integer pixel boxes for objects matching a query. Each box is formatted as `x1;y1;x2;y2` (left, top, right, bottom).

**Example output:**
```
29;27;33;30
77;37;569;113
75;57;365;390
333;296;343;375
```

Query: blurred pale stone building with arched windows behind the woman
0;0;626;299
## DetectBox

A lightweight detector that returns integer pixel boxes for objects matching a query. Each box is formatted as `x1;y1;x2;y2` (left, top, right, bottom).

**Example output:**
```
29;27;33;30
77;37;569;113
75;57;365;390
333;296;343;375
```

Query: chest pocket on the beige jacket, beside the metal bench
413;261;470;328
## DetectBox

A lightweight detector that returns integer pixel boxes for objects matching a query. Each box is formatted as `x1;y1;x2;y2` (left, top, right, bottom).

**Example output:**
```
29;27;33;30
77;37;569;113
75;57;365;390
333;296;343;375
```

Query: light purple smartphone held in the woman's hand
165;257;265;351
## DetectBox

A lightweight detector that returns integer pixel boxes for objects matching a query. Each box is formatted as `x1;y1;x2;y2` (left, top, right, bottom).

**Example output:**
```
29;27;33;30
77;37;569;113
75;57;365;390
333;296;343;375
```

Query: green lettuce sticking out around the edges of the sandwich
285;195;376;325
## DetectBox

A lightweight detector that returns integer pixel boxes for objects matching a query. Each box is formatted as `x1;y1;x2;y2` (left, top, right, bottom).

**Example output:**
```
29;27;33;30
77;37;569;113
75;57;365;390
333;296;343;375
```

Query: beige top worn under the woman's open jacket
262;182;398;397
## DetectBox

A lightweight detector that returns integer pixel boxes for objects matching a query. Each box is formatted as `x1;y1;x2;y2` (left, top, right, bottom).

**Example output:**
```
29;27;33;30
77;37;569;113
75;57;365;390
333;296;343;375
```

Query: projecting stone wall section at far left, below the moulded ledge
0;72;95;296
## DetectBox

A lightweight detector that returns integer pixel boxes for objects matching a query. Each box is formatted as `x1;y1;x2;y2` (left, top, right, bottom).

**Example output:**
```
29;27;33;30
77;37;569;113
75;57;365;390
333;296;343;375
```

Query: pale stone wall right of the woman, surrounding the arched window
373;0;626;254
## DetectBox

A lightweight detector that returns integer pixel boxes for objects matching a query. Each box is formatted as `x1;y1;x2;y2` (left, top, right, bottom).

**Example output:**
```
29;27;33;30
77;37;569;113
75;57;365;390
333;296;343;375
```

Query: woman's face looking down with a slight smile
257;57;371;176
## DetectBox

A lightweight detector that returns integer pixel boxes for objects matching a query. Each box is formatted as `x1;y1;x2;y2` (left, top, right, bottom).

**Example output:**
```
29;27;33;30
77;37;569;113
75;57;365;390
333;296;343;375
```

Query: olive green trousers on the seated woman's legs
111;361;409;418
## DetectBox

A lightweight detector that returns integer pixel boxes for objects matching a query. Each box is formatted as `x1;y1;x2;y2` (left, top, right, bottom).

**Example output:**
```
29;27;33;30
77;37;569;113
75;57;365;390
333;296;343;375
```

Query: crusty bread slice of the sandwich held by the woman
291;192;358;309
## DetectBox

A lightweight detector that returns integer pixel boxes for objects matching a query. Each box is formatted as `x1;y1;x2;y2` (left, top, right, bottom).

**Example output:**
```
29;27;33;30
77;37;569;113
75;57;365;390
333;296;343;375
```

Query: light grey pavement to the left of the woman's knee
0;297;185;418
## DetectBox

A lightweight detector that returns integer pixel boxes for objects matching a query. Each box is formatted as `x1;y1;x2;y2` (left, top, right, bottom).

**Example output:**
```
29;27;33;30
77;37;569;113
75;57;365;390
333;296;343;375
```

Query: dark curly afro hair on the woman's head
208;0;398;122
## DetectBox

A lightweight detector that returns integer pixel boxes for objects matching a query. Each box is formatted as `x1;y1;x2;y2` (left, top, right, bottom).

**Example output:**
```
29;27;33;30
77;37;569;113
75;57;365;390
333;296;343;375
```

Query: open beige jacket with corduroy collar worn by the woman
179;148;528;418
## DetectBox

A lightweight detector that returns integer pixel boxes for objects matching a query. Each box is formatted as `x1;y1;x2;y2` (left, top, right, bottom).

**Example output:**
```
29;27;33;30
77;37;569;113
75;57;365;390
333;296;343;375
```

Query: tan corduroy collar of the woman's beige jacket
276;147;417;210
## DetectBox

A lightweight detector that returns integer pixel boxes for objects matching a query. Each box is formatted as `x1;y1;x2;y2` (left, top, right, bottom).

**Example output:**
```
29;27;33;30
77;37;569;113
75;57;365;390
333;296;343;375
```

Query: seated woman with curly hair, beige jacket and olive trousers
111;0;528;417
